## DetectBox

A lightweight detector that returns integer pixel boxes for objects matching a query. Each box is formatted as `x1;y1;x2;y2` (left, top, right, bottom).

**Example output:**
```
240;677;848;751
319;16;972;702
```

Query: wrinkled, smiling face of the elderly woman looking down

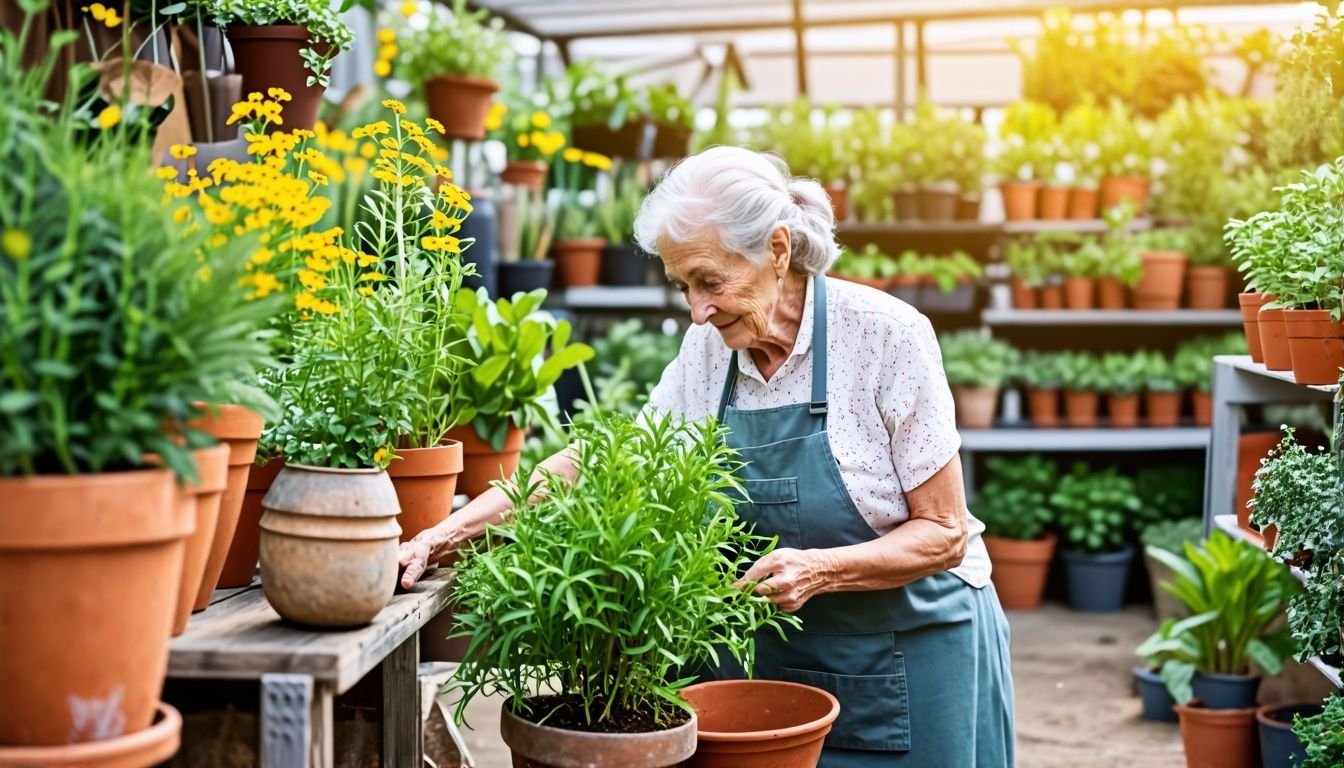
659;227;789;350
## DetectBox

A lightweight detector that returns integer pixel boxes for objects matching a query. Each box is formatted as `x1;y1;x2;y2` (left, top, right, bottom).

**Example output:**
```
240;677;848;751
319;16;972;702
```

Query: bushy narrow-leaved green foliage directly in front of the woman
450;416;798;730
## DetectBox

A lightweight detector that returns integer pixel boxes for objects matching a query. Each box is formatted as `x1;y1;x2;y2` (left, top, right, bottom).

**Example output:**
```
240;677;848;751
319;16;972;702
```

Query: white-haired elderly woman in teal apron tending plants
402;147;1013;768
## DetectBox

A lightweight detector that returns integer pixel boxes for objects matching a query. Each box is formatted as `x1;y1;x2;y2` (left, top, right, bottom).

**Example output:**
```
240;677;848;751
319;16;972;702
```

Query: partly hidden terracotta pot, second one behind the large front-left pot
191;403;263;599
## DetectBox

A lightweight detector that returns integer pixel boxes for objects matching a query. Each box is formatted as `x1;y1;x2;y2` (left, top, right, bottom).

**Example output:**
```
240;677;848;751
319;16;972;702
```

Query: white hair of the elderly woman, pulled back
634;147;840;274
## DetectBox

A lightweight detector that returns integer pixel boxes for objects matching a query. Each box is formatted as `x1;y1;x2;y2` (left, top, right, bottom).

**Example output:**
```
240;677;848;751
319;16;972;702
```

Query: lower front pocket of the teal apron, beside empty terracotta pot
780;661;910;752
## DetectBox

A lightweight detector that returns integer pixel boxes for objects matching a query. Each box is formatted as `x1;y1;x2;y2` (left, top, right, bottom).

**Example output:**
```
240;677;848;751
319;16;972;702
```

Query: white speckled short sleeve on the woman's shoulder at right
878;316;961;492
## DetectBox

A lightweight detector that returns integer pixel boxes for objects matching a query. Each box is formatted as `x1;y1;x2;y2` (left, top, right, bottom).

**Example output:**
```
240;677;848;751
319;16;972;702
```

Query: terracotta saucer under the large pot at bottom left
0;702;181;768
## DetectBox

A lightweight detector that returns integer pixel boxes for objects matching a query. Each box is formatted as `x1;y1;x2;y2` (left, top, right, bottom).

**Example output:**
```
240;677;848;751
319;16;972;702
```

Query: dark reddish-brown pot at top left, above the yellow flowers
227;24;327;132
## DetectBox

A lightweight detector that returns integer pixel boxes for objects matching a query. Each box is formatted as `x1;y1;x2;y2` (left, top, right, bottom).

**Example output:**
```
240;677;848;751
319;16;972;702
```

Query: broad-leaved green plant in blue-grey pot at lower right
1137;530;1297;703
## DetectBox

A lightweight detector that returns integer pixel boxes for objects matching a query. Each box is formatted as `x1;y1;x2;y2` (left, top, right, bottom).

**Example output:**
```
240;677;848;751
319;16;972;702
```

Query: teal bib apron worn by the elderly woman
715;276;1013;768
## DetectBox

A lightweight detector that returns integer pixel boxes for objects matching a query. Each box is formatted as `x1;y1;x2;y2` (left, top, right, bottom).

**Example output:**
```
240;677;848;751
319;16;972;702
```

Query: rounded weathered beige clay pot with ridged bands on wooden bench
261;464;402;627
